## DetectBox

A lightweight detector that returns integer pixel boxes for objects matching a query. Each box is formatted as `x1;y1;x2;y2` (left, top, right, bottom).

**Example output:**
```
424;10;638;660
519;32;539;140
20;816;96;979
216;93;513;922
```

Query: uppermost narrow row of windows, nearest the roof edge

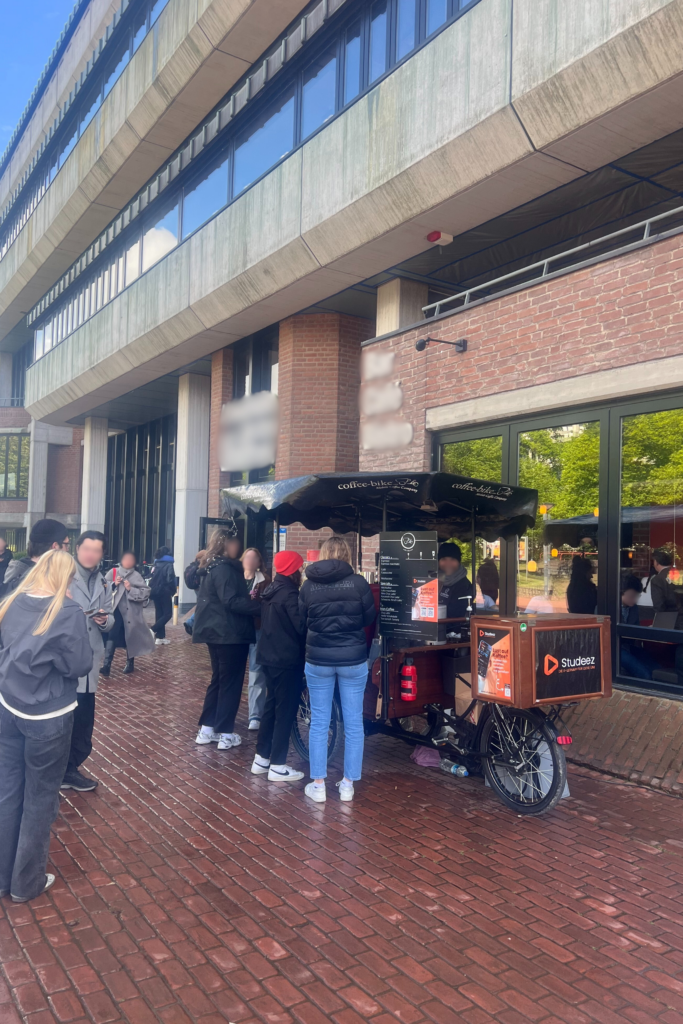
0;0;168;259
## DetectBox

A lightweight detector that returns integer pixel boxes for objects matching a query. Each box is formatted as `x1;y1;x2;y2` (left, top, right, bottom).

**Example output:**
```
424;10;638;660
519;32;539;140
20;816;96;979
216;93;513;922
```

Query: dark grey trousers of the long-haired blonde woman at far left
0;707;74;899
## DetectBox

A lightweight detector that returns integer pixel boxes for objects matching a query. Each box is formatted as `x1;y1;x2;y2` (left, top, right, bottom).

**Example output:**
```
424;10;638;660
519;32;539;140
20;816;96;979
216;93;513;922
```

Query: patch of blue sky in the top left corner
0;0;75;154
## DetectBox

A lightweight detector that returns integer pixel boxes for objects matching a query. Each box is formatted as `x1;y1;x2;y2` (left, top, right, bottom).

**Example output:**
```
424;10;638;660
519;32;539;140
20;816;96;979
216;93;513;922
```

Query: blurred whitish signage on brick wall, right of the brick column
358;349;413;452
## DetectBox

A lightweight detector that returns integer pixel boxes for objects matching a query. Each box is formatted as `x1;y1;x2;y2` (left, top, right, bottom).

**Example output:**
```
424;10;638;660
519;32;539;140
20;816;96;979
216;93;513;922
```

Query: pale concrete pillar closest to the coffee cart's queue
173;374;211;611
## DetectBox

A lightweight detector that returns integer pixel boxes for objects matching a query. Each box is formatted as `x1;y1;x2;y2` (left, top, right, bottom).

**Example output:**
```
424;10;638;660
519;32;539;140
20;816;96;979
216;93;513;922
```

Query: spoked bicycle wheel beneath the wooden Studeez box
479;708;567;814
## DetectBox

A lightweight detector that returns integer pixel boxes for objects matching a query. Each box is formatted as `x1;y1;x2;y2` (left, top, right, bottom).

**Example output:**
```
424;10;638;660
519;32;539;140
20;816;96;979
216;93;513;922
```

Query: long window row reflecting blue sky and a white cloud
35;0;476;358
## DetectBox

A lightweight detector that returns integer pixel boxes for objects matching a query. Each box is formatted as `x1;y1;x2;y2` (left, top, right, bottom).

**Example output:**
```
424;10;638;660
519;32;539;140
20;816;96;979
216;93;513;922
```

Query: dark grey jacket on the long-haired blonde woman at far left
0;594;93;715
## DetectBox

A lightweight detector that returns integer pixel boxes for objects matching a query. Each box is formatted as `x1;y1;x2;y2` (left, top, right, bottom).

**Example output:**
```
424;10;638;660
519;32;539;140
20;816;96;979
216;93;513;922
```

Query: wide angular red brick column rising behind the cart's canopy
275;313;375;480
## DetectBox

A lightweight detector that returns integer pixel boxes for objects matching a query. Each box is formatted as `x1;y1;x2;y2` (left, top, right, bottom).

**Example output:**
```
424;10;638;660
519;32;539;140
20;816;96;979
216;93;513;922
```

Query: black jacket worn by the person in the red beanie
256;572;306;671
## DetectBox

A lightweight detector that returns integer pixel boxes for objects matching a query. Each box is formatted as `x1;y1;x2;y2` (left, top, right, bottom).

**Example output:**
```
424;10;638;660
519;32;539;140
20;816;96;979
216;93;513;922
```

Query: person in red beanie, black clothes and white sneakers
251;551;305;782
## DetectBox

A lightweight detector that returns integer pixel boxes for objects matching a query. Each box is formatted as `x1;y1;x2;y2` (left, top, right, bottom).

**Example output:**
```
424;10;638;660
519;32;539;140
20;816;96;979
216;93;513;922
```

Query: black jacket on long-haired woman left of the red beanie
193;558;261;643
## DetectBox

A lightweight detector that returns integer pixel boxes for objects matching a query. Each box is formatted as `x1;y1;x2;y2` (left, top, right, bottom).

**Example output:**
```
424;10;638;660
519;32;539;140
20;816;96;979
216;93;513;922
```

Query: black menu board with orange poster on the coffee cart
380;530;438;643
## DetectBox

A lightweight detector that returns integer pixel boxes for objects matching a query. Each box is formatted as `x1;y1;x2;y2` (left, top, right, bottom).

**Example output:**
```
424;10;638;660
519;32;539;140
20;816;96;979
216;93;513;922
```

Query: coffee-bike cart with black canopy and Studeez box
221;472;611;814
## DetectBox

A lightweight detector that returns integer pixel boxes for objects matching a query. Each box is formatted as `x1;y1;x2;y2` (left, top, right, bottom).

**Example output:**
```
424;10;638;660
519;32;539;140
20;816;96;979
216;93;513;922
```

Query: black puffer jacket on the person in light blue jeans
299;558;377;666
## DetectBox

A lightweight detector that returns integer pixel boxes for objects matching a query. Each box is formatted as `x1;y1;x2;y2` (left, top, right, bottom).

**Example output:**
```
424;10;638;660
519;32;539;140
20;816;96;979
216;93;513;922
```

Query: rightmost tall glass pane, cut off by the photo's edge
616;409;683;687
